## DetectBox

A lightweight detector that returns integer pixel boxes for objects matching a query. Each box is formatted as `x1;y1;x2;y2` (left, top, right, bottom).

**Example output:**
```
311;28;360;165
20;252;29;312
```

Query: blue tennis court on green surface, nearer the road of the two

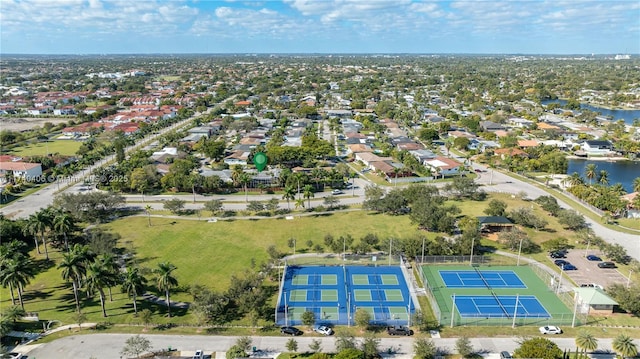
453;295;551;318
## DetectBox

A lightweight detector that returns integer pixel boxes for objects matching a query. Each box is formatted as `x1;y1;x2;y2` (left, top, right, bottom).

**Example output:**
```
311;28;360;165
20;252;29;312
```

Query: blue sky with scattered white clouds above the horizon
0;0;640;54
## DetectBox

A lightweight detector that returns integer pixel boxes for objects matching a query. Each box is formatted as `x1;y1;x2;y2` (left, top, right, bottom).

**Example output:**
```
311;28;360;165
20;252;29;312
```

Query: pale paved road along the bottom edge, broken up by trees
19;334;611;359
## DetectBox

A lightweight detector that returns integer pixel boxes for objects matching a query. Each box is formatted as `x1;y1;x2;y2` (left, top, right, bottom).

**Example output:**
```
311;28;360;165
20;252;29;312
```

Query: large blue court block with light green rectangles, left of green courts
275;266;415;325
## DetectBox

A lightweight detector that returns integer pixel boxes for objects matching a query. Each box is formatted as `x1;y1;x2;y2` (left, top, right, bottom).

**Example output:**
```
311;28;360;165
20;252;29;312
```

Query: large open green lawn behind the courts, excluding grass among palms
105;211;416;290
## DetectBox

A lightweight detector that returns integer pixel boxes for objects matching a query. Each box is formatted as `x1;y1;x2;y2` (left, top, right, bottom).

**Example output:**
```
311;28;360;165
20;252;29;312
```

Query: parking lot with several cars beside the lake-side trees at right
547;249;628;289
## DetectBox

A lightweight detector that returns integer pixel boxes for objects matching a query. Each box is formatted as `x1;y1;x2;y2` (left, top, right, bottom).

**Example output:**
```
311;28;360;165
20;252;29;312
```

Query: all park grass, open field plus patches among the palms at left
0;212;424;330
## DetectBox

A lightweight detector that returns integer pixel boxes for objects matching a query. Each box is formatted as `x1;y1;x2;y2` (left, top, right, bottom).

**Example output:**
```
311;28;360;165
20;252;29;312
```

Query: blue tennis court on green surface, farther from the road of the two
438;270;527;288
